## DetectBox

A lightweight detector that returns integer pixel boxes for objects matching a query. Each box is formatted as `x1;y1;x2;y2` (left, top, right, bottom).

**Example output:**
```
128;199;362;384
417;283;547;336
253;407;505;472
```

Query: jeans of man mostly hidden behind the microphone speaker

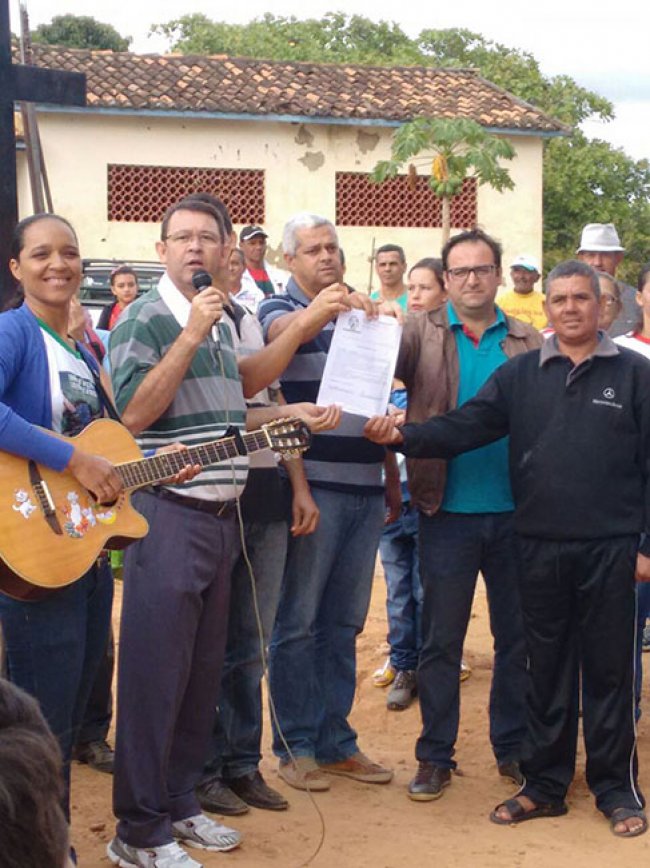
205;521;289;780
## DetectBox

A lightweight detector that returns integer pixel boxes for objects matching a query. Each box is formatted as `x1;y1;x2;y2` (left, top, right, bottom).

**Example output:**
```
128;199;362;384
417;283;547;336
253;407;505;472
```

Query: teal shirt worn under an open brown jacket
441;302;514;513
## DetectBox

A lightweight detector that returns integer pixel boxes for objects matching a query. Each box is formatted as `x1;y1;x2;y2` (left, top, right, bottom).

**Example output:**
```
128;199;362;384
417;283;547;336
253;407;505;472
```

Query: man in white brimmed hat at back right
576;223;642;338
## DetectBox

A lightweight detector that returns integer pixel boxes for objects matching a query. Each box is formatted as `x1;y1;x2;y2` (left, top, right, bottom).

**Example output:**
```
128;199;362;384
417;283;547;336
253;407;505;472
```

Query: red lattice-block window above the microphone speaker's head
108;165;264;223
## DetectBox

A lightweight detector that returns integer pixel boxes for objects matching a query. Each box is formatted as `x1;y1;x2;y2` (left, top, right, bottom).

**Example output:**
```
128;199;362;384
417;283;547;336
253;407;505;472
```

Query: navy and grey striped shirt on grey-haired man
258;278;385;494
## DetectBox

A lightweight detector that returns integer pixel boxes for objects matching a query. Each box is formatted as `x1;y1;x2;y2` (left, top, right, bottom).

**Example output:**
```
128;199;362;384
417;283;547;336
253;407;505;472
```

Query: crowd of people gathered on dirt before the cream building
0;205;650;868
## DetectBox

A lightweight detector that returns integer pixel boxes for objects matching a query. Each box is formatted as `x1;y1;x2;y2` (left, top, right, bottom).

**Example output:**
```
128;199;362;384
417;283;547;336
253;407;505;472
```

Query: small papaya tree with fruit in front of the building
372;118;515;244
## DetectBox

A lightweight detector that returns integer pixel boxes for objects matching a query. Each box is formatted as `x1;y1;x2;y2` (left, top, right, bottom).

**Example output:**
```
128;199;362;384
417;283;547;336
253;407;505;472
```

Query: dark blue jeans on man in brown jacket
416;512;526;768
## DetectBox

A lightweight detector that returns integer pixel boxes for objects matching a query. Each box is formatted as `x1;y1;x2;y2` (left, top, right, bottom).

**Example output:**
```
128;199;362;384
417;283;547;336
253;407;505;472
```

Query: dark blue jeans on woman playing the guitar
0;558;113;818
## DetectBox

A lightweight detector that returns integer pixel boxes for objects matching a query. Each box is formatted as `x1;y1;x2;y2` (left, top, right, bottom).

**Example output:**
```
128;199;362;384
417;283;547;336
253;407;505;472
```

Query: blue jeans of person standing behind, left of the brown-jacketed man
379;503;423;671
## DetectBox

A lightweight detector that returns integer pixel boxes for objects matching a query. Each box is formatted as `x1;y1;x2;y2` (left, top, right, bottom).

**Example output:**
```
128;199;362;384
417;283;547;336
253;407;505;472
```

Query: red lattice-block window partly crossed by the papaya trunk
336;172;477;229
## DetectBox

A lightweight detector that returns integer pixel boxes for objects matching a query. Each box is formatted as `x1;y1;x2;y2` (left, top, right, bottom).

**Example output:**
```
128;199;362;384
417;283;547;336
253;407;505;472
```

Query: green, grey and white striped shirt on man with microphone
110;274;248;500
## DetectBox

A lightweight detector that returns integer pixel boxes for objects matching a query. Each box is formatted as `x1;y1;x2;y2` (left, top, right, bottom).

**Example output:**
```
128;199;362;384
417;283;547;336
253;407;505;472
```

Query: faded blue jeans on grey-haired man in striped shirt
269;487;384;762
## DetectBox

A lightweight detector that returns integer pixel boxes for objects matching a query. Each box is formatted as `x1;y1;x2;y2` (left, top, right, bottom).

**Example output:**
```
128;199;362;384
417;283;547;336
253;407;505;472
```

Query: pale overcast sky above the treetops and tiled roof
10;0;650;159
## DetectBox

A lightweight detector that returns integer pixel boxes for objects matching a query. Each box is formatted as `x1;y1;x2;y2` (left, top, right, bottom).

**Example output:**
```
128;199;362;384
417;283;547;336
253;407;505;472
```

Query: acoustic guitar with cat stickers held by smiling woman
0;419;311;600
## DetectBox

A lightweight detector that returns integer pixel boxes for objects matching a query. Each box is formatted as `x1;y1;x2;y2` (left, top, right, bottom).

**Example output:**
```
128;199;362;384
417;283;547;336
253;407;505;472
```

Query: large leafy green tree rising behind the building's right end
408;30;650;274
